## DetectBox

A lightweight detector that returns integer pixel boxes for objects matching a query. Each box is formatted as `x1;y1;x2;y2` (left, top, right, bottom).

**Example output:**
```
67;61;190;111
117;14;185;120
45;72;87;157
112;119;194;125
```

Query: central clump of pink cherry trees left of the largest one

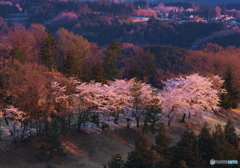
76;79;160;132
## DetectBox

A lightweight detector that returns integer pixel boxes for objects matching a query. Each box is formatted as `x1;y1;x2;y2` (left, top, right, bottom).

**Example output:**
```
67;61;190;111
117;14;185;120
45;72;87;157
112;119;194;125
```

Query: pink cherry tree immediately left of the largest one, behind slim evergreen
101;78;161;128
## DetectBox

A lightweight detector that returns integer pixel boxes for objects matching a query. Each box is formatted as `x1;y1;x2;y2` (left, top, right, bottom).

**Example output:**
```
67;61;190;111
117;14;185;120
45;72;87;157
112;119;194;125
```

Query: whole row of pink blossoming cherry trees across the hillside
0;74;226;137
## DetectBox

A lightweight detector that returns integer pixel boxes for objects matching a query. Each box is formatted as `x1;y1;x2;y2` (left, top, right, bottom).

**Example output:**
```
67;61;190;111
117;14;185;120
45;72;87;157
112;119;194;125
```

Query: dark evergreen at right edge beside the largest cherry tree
221;67;240;110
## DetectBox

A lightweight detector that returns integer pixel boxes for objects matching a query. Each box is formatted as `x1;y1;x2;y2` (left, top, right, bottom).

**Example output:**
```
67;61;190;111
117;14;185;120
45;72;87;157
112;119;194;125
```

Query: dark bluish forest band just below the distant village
61;15;226;48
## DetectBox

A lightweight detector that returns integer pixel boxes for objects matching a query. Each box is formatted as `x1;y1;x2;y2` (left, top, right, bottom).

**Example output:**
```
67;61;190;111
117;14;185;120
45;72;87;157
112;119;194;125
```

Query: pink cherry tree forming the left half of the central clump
75;81;120;132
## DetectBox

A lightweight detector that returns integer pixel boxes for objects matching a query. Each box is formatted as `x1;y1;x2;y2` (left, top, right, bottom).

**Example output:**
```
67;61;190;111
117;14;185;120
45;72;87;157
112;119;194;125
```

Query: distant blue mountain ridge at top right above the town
158;0;240;6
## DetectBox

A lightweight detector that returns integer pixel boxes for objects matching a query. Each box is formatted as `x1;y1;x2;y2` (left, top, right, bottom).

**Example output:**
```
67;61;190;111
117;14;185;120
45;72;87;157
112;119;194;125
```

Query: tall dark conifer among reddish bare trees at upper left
40;32;57;71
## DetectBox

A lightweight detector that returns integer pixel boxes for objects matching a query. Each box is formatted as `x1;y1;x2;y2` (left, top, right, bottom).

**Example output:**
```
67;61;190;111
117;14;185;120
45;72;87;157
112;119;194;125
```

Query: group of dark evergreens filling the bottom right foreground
104;120;239;168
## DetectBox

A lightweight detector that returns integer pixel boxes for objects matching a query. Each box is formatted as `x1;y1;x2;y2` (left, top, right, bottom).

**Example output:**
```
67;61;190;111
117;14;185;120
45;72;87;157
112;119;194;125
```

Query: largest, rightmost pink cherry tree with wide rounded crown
162;74;226;125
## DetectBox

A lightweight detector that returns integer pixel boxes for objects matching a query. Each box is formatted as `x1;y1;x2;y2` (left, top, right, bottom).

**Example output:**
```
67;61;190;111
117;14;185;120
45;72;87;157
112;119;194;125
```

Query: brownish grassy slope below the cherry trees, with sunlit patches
0;110;240;168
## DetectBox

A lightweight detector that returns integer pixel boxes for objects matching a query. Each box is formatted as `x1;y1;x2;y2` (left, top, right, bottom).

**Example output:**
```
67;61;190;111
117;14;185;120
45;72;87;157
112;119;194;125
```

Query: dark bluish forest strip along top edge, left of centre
21;0;133;23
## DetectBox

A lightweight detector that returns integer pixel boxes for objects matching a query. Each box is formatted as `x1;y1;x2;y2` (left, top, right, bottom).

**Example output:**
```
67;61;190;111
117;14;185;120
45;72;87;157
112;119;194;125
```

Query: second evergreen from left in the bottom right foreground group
124;134;154;168
